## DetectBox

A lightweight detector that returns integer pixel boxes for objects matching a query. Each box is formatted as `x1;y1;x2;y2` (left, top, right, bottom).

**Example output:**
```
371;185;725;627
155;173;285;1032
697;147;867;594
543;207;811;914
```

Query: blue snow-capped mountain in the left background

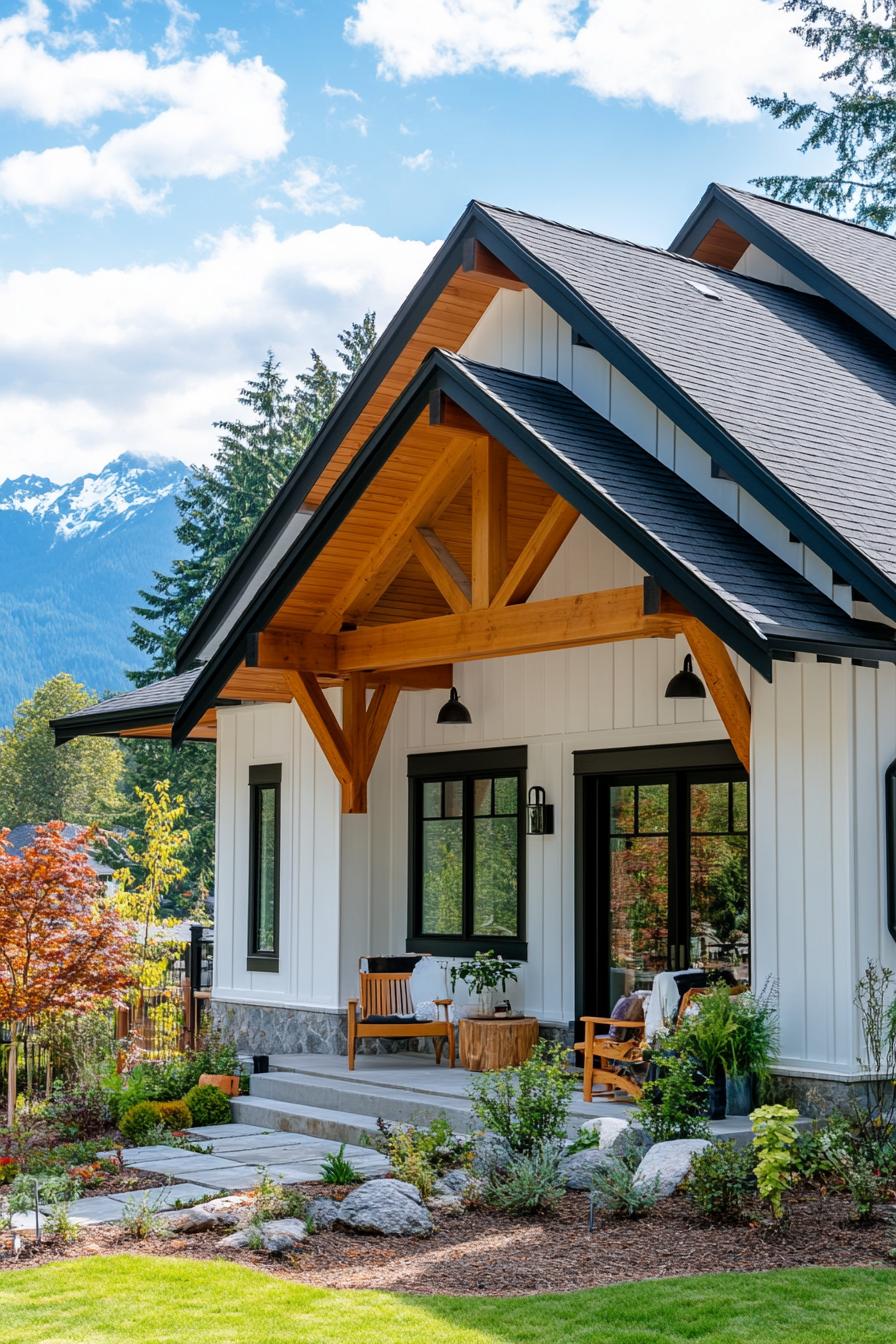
0;453;188;726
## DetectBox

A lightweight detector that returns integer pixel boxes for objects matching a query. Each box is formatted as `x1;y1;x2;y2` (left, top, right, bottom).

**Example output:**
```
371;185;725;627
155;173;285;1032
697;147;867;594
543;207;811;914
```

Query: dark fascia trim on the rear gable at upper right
669;181;896;360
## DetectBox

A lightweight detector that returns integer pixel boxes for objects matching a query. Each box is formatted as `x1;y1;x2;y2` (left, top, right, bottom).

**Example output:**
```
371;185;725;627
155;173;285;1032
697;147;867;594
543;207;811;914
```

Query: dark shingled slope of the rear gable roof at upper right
716;185;896;329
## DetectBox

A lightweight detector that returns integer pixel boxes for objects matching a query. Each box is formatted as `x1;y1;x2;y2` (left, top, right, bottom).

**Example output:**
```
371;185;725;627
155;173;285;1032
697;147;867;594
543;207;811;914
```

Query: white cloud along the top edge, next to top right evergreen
345;0;821;121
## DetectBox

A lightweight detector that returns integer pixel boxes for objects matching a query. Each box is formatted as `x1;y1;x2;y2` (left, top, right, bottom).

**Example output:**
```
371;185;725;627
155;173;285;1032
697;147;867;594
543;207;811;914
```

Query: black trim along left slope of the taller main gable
177;203;483;672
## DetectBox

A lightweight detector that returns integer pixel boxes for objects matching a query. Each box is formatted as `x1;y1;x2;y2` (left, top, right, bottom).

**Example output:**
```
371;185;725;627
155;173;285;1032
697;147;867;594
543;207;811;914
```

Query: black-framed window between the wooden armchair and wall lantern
407;747;525;957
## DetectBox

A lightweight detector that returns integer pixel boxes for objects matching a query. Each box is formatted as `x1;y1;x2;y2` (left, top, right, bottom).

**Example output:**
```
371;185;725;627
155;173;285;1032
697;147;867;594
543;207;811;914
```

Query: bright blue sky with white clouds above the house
0;0;832;480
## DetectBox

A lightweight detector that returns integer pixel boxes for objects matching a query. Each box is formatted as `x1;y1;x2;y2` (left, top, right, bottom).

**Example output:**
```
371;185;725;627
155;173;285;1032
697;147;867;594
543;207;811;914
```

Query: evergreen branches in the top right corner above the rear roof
751;0;896;228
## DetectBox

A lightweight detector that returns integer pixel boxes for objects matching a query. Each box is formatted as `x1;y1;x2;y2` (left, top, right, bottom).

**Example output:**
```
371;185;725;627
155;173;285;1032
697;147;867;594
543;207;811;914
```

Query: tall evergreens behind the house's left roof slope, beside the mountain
121;313;376;907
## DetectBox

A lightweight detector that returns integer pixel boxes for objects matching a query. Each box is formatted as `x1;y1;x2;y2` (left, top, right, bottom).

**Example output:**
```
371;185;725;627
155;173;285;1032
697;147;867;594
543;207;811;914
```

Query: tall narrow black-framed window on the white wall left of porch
246;765;282;970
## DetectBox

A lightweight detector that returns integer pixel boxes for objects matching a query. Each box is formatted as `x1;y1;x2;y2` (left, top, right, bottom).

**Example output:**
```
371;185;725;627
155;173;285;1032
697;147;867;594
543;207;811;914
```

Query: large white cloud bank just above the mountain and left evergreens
0;223;438;480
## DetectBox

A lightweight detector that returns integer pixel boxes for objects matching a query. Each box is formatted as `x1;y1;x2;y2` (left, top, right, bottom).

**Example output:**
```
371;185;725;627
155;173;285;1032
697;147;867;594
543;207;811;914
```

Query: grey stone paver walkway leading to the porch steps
12;1125;388;1231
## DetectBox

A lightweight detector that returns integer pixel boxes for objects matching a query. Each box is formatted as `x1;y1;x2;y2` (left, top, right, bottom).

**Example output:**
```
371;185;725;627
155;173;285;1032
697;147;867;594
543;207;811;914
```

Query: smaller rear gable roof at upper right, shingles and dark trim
669;183;896;348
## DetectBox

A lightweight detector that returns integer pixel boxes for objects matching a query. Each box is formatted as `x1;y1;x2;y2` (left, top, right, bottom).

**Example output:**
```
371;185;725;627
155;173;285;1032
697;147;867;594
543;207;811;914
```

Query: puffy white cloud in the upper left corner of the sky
0;3;289;211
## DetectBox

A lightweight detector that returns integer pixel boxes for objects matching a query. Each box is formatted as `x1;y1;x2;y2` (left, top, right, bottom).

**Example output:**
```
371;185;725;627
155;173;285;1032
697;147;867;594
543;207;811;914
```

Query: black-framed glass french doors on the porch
579;750;750;1013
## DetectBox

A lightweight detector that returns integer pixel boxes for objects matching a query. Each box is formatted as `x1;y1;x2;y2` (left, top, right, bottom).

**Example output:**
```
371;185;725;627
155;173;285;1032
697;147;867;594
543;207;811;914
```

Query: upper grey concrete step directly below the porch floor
250;1070;473;1133
